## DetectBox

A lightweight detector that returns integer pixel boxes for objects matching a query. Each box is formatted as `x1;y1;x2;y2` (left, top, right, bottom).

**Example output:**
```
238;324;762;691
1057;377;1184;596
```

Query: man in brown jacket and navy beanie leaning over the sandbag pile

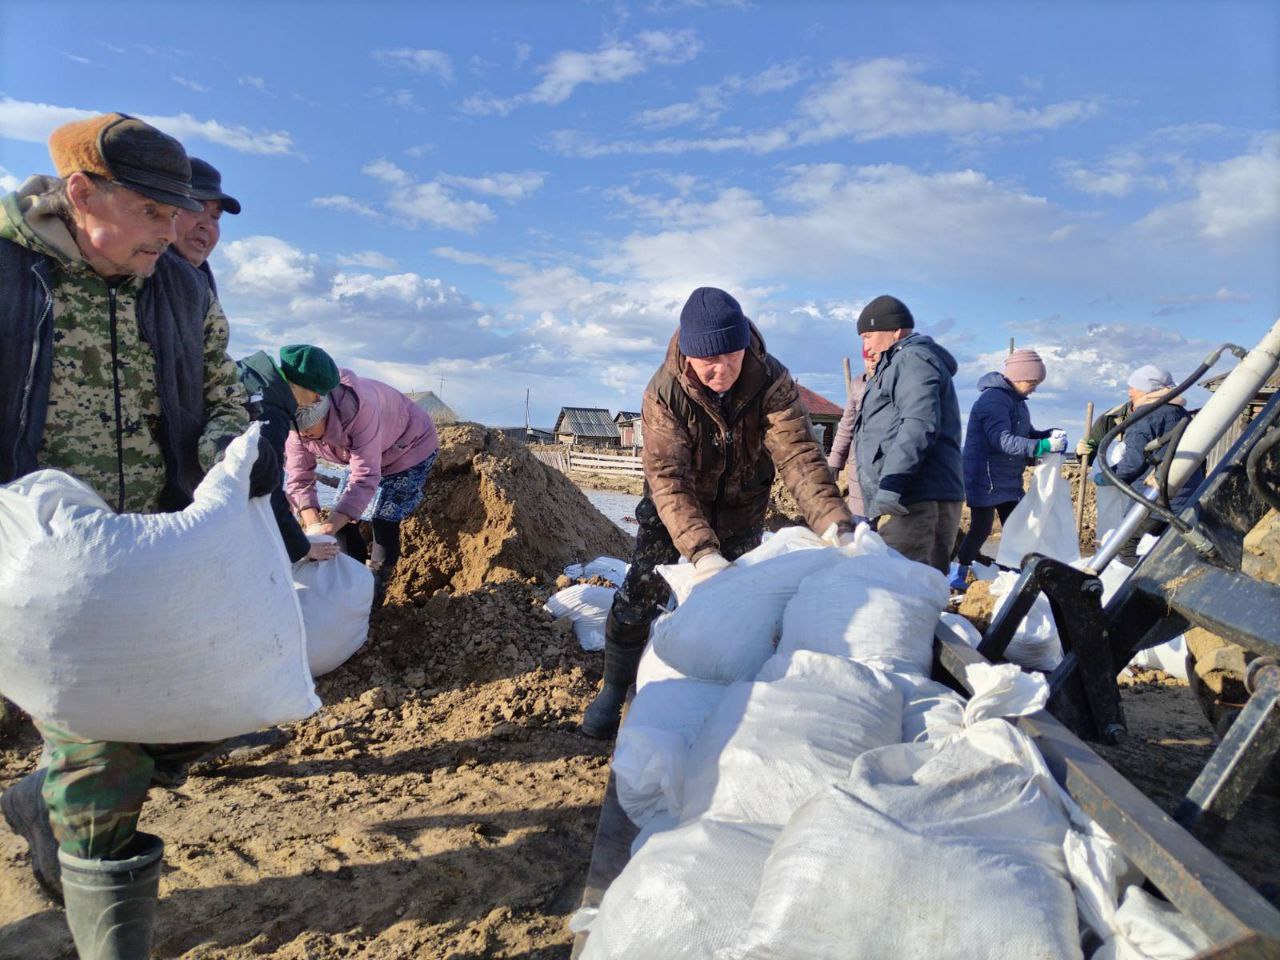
582;287;854;740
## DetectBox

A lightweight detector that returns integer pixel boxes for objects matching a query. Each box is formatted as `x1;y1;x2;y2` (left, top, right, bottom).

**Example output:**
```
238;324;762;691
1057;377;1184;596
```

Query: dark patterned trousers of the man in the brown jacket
604;497;764;684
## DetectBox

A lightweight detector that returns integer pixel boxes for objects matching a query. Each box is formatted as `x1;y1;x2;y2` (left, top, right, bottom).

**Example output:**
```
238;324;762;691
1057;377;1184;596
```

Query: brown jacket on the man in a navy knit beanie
643;325;852;561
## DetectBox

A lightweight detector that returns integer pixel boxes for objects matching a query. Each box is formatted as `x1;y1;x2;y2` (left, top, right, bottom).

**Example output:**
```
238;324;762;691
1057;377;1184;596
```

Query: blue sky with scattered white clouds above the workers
0;0;1280;436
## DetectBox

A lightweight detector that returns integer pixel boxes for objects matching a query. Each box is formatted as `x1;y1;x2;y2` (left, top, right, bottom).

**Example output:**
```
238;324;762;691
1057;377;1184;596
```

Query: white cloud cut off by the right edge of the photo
1139;133;1280;243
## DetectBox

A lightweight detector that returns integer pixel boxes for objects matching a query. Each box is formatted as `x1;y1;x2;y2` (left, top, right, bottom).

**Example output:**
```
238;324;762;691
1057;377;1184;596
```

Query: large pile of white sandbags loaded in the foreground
575;527;1206;960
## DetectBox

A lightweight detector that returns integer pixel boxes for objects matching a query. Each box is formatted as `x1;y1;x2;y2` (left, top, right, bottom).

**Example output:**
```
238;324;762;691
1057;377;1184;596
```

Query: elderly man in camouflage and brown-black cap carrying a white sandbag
0;114;267;957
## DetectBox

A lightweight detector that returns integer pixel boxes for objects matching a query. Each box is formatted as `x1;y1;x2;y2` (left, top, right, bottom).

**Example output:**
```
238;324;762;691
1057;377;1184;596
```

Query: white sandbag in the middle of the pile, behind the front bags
681;650;902;826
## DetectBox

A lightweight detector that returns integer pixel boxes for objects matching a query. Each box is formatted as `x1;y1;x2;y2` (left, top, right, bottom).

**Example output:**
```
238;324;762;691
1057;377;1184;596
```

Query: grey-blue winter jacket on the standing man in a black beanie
854;333;964;506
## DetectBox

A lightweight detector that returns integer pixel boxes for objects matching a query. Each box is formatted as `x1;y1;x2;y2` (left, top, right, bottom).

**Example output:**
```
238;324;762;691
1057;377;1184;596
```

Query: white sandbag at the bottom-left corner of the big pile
582;820;778;960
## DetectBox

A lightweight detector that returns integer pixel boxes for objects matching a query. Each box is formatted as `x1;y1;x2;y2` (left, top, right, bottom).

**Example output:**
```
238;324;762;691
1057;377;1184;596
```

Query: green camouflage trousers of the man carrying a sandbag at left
38;724;210;860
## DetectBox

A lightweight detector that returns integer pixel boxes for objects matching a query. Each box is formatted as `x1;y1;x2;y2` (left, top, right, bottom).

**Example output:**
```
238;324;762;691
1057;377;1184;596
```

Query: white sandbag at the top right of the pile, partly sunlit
778;547;950;675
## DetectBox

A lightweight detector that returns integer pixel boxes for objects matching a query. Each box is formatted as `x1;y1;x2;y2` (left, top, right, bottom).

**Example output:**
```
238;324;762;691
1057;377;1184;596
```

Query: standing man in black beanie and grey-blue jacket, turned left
854;296;964;573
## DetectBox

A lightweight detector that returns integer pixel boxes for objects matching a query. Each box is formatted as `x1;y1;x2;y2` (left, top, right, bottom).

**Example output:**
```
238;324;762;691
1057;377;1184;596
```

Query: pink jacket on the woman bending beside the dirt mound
284;369;440;517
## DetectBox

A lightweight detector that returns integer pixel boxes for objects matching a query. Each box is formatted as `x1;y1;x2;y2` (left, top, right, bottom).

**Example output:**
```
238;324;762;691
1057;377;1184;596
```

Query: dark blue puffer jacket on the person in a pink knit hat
964;370;1050;507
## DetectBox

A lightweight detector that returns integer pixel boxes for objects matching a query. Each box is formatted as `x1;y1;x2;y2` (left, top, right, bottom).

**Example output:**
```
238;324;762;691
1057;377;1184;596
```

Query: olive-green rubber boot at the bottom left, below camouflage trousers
58;833;164;960
